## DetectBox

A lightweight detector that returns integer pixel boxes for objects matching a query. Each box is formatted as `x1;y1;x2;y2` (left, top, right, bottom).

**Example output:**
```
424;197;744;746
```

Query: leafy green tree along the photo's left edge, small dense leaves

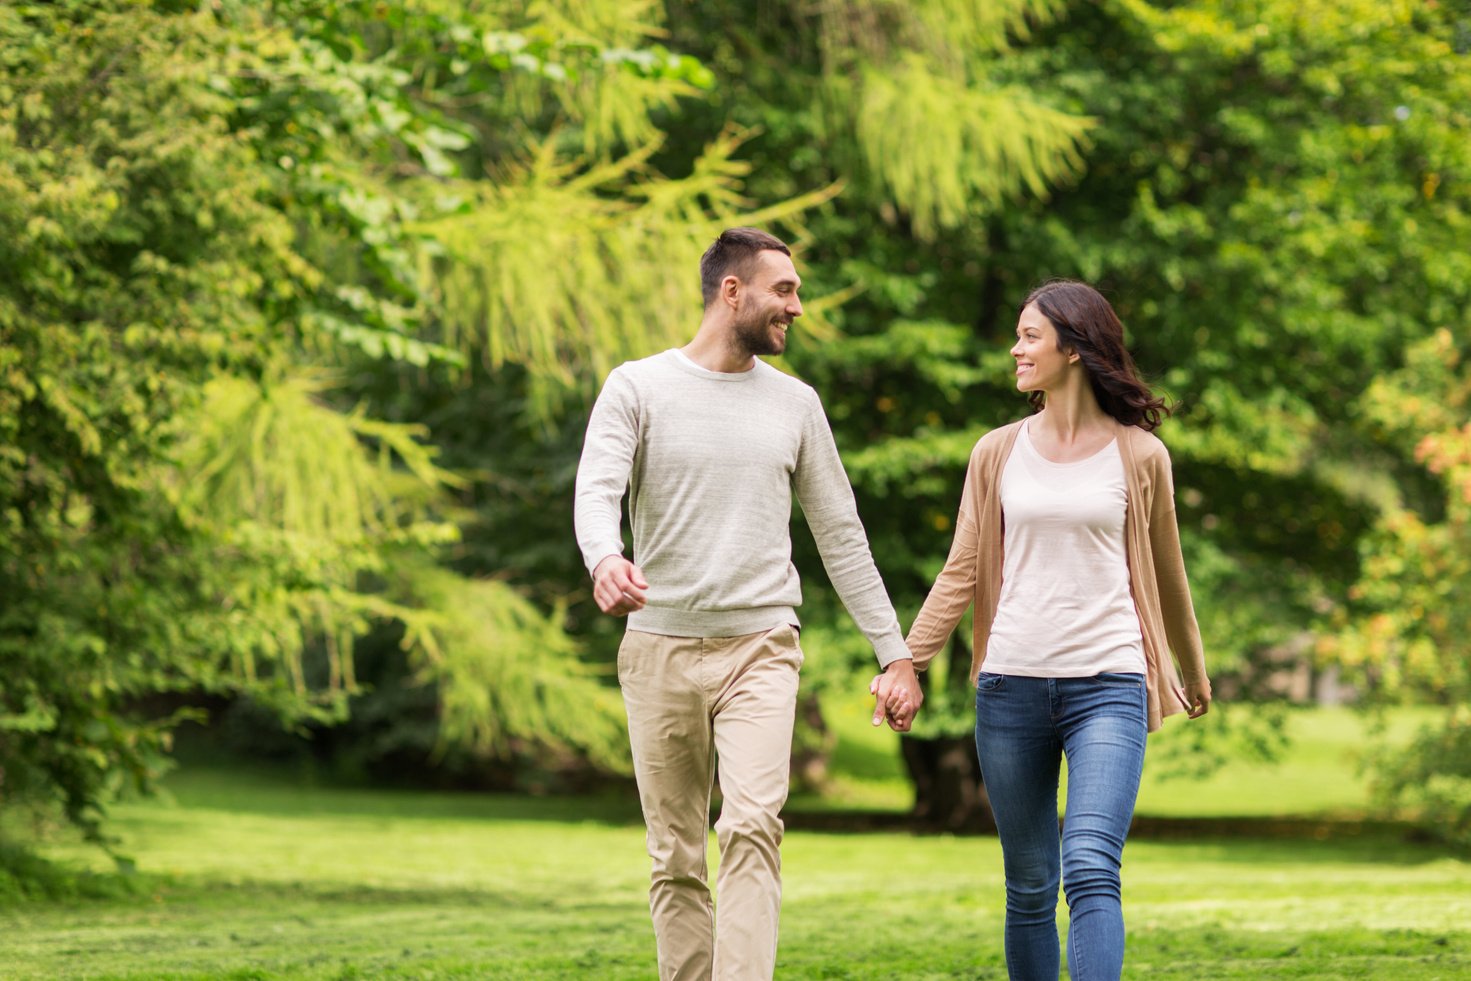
0;4;336;837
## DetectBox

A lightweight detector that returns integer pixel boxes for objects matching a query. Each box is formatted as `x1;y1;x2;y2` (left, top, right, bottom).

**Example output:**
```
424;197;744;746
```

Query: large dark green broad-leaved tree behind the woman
667;1;1468;819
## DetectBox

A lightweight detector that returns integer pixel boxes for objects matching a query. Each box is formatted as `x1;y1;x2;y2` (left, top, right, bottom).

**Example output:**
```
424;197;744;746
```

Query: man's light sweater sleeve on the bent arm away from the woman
572;368;638;575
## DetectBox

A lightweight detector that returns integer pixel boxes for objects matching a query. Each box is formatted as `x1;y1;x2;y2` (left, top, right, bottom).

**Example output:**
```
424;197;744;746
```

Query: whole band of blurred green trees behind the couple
0;0;1471;834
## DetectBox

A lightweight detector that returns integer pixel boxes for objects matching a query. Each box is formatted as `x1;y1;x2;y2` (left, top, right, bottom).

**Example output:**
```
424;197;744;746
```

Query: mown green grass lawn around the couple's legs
0;708;1471;981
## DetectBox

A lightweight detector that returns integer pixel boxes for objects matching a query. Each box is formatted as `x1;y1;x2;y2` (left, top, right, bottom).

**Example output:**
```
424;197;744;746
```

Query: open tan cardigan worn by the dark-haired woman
906;422;1206;732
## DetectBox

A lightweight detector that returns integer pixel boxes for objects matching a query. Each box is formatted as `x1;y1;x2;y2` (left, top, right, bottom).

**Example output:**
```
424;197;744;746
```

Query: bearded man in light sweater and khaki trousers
575;228;922;980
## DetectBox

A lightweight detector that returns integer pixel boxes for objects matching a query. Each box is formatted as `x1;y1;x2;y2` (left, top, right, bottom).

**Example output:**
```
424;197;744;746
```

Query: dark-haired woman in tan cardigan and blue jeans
890;281;1211;981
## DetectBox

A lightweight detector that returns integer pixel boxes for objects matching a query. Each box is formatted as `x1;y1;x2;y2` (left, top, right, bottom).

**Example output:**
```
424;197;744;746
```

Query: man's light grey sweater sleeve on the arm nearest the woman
793;393;909;668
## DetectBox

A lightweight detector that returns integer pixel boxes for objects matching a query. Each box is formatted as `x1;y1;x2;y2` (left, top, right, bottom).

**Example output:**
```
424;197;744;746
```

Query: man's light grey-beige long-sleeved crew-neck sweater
574;350;909;668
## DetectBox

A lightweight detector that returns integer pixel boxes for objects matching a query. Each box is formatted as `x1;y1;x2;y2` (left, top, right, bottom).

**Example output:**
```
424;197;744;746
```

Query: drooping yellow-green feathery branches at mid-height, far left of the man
175;375;457;708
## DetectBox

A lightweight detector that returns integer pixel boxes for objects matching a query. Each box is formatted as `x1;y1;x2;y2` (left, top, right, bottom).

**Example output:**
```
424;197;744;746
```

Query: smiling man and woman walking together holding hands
575;228;1211;981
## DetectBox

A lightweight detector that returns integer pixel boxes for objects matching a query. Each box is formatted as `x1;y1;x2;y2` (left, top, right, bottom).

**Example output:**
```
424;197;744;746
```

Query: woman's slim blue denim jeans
975;672;1149;981
